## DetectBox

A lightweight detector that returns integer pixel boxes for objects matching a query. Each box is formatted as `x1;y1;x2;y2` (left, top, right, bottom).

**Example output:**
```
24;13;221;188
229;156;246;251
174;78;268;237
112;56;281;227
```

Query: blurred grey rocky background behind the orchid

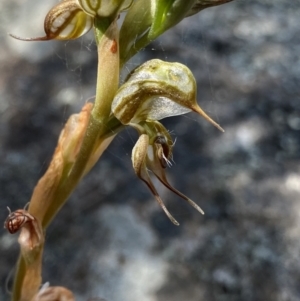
0;0;300;301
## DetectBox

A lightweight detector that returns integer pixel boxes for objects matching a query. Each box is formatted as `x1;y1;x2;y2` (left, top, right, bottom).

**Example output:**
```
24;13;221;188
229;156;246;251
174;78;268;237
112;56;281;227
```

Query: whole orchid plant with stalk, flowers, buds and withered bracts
5;0;231;301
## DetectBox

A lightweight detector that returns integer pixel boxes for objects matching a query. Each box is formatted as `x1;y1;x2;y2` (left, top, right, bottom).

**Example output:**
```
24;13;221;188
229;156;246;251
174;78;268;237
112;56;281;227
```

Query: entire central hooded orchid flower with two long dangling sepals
112;59;224;225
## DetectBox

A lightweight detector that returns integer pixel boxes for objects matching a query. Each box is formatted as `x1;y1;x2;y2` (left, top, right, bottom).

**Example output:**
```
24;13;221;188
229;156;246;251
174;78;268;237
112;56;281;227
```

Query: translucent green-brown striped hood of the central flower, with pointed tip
112;59;224;131
